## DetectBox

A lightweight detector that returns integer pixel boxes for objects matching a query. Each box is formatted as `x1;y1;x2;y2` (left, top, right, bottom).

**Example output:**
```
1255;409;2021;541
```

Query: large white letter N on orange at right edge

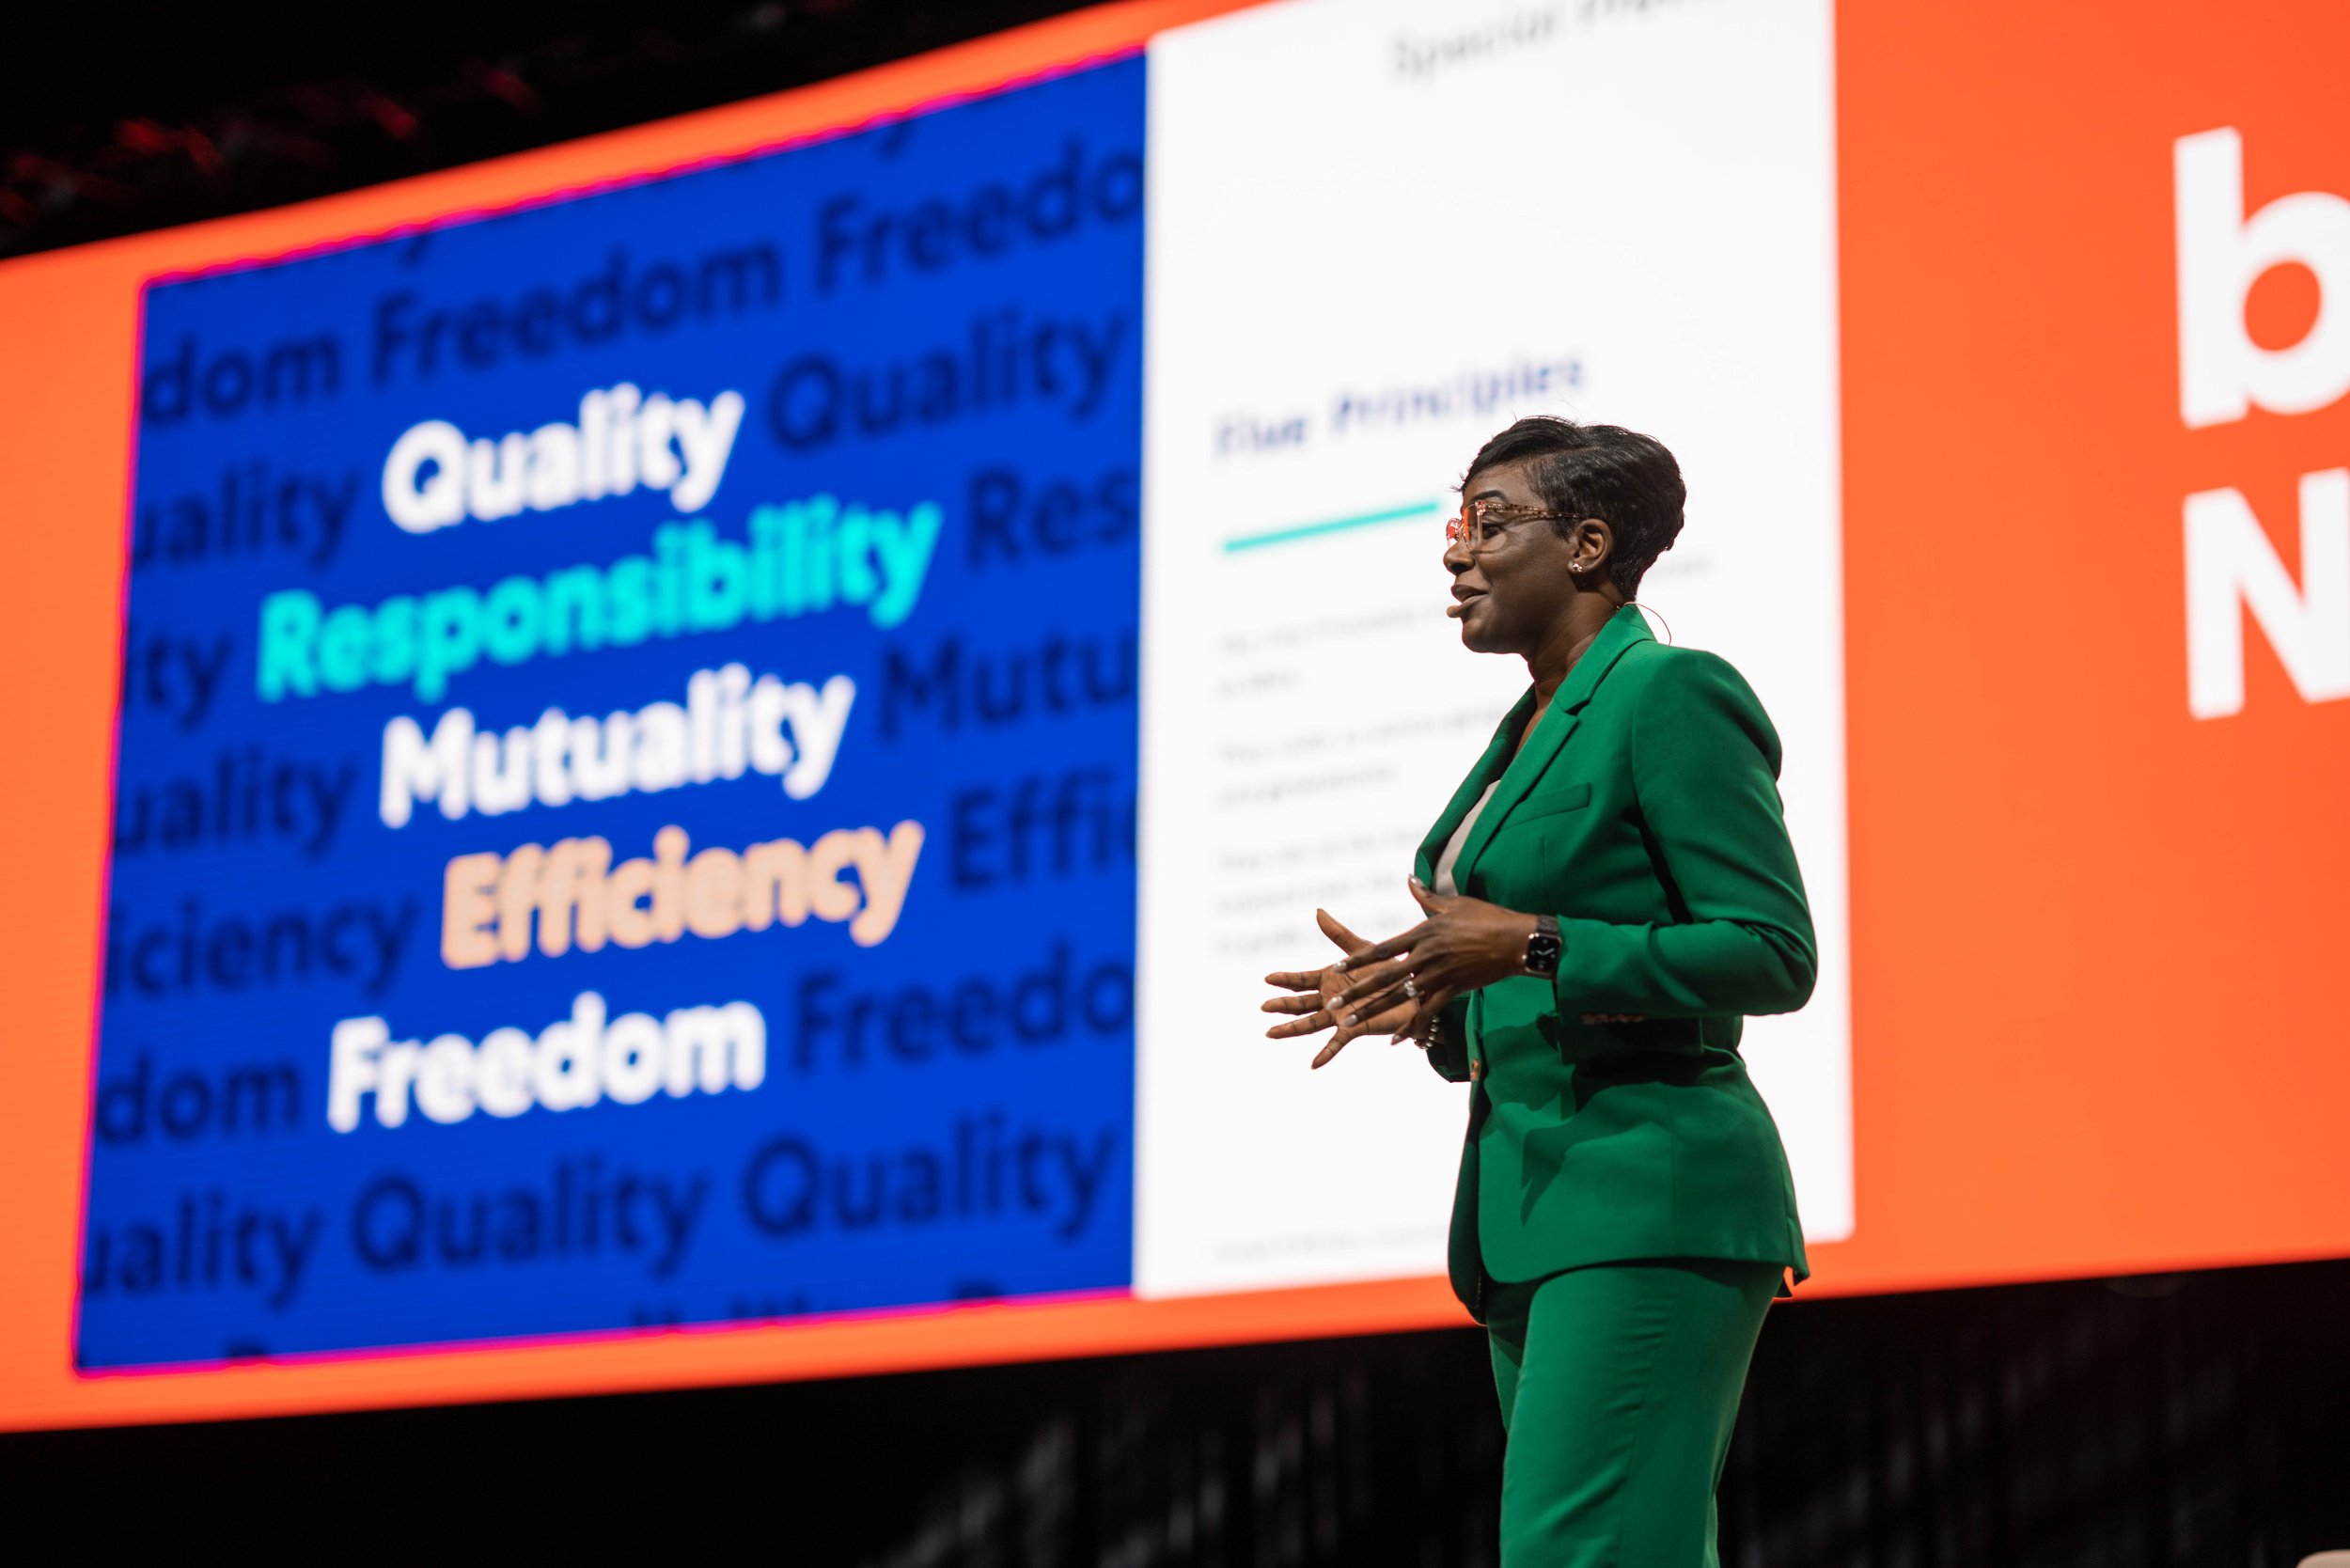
2186;468;2350;719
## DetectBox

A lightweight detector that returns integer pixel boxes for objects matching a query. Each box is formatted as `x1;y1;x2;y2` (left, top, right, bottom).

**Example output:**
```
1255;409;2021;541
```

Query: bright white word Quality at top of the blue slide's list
384;381;743;534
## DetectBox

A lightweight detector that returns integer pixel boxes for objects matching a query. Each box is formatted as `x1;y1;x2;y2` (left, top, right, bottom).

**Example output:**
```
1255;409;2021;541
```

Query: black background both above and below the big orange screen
0;0;2350;1568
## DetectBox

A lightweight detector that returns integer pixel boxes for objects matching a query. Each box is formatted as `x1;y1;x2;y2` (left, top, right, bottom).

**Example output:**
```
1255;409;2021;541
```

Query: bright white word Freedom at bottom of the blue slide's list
327;992;766;1133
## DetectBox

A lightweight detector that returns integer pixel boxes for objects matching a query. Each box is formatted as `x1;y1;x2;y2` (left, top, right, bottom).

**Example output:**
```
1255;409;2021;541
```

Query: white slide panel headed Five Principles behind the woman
1136;0;1852;1295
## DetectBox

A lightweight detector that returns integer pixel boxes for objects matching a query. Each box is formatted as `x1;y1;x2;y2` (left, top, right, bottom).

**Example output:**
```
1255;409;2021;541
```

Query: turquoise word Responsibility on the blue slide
254;496;945;703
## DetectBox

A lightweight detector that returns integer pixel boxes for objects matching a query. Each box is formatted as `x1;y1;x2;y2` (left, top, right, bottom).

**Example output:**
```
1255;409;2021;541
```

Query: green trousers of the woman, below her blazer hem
1485;1258;1781;1568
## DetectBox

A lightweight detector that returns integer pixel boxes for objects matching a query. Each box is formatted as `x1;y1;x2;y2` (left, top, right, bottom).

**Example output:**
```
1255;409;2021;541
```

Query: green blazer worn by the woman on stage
1419;604;1817;1319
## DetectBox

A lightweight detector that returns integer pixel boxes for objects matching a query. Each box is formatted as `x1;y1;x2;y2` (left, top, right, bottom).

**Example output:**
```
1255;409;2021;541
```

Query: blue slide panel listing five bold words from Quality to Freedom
75;59;1142;1371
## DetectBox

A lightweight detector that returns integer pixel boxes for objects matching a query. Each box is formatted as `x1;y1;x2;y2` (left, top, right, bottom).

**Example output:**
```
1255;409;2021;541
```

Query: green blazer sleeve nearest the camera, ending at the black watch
1559;651;1819;1018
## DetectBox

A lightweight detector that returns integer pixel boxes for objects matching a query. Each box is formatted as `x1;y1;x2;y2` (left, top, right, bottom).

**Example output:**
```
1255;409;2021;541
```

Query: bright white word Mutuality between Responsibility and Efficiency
376;666;858;827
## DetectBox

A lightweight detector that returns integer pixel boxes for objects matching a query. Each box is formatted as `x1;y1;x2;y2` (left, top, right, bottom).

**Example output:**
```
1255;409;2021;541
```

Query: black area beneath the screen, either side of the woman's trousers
0;1262;2350;1568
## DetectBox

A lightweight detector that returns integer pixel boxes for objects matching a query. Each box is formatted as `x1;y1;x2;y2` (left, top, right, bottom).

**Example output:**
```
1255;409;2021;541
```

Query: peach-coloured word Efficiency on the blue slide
442;821;924;968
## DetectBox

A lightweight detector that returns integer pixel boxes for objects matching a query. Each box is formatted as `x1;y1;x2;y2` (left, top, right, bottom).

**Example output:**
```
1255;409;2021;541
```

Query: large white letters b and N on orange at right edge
2171;130;2350;719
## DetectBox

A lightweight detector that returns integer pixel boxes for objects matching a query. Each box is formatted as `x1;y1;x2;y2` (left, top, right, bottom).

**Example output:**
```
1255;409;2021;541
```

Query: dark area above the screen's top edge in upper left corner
0;0;1100;261
